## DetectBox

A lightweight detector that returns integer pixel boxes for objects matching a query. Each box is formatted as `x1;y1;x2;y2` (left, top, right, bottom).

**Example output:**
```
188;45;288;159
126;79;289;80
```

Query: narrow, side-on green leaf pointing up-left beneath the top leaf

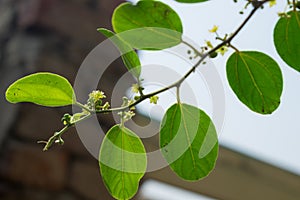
97;28;141;78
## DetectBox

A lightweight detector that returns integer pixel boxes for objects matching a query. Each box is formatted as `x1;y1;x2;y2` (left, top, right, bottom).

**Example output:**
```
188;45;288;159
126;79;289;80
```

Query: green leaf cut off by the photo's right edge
274;11;300;72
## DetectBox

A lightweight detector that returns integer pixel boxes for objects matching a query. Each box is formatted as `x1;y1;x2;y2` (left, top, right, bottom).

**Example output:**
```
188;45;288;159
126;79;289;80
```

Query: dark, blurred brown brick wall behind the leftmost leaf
0;0;125;200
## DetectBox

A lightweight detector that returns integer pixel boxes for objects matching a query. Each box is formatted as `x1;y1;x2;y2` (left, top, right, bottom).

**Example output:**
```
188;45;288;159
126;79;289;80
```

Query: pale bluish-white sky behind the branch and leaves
126;0;300;175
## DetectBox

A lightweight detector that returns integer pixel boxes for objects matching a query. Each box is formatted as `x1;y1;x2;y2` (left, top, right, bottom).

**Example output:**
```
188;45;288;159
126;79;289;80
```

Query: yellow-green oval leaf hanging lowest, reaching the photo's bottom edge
99;125;147;199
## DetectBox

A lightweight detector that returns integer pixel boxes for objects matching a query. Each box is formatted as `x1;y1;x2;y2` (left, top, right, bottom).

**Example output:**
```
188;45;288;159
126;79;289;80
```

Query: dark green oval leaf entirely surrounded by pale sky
226;51;283;114
